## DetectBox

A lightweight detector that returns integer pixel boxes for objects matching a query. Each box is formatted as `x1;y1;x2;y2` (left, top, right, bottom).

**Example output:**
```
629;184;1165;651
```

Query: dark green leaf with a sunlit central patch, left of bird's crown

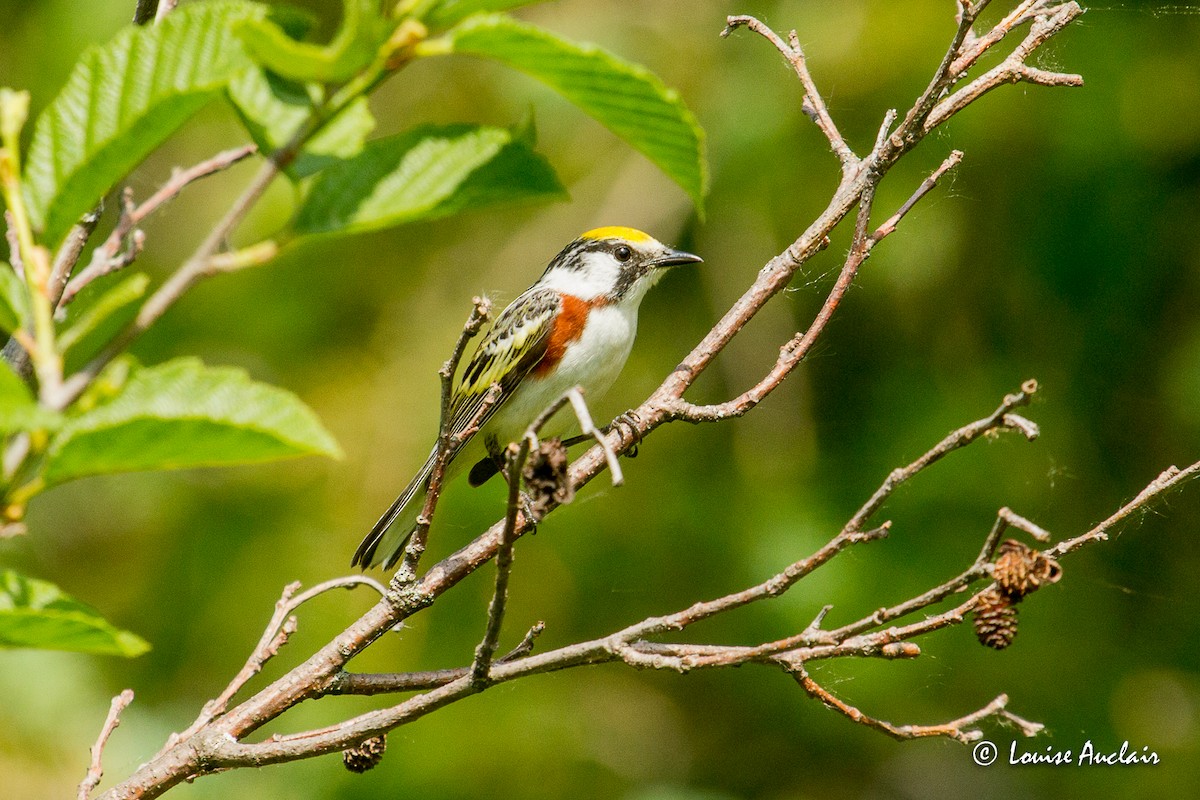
294;125;565;234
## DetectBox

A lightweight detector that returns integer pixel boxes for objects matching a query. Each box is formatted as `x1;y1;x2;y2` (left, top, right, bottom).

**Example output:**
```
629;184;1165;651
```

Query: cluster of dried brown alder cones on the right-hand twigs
974;539;1062;650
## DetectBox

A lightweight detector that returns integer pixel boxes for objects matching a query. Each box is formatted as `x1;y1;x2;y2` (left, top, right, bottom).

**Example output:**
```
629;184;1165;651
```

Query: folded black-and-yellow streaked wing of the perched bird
450;289;563;445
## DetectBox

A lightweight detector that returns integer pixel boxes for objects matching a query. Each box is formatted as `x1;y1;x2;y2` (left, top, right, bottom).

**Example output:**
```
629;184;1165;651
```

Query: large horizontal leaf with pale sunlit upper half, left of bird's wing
46;359;341;485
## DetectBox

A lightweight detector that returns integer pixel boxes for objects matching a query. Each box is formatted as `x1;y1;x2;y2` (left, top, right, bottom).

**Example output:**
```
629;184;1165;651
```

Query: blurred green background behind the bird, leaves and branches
0;0;1200;800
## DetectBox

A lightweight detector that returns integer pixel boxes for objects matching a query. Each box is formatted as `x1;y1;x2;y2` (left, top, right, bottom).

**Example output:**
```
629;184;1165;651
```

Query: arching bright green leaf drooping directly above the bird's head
436;14;708;212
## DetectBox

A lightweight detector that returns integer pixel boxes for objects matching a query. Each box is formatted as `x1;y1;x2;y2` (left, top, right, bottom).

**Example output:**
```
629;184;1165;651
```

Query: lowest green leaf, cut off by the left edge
0;570;150;658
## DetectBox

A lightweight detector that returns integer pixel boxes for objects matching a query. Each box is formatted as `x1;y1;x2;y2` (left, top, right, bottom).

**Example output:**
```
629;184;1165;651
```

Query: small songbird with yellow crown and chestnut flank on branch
350;227;701;570
